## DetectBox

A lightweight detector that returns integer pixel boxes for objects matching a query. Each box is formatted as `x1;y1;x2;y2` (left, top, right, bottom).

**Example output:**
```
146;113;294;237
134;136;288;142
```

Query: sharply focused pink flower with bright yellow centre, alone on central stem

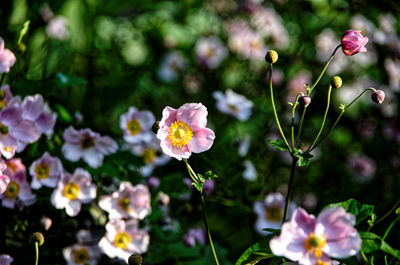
157;103;215;160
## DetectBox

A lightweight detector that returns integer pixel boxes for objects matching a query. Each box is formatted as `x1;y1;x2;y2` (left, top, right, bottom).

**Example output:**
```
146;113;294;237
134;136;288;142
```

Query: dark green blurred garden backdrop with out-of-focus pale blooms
0;0;400;265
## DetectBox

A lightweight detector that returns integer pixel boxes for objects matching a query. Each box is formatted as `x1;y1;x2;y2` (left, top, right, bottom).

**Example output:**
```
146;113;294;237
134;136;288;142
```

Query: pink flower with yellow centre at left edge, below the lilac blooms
0;158;36;209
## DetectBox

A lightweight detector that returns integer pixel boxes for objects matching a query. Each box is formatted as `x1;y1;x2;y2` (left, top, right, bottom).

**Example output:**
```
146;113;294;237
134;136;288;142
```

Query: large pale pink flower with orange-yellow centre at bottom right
270;207;361;265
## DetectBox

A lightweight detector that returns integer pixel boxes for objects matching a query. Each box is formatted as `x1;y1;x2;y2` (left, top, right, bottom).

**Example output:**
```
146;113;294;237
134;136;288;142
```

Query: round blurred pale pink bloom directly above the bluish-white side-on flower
195;36;228;69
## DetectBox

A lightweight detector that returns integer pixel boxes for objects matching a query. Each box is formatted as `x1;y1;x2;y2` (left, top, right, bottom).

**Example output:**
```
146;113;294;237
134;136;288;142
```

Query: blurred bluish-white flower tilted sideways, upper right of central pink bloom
212;89;253;121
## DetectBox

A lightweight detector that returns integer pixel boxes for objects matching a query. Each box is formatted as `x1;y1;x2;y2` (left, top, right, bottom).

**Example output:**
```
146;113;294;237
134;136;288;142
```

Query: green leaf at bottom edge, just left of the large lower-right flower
236;234;275;265
